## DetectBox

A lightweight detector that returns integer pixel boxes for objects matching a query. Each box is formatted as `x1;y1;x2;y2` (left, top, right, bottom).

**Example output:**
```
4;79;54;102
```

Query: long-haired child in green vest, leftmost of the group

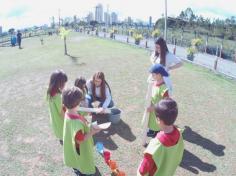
47;70;67;144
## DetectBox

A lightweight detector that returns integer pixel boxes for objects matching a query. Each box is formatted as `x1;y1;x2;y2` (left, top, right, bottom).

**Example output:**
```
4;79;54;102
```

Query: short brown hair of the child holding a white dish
62;86;84;109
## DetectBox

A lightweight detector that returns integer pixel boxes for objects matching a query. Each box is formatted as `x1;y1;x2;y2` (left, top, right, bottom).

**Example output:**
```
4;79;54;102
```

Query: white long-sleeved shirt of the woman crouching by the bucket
86;80;111;108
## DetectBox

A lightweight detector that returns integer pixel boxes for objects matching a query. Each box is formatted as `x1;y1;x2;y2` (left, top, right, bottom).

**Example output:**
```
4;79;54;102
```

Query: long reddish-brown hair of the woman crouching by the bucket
92;72;111;101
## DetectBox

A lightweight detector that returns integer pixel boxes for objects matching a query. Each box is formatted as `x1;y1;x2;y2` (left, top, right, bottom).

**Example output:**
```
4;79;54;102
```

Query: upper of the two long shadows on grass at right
183;126;225;156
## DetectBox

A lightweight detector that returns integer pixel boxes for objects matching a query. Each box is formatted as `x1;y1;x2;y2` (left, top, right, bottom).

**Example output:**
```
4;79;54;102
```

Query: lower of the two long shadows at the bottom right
180;150;216;174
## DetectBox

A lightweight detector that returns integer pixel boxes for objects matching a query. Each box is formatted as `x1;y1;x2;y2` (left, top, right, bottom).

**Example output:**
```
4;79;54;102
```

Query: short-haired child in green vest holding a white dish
62;87;100;176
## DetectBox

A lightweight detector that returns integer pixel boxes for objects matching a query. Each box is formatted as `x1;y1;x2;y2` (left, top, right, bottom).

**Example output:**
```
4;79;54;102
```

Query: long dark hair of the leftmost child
47;70;68;97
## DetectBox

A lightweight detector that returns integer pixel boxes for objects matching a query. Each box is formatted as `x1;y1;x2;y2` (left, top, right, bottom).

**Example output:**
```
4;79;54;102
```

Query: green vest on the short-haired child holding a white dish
63;117;96;175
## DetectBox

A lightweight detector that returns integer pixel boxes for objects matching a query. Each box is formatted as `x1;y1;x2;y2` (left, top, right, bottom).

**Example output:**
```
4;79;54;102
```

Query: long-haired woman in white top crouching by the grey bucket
86;72;114;113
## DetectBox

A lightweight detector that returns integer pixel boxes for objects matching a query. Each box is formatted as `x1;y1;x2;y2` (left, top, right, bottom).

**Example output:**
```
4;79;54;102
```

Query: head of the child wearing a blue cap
149;64;169;81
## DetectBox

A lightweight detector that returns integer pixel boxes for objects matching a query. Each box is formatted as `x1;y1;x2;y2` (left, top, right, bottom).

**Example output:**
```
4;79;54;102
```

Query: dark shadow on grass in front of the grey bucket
93;116;136;150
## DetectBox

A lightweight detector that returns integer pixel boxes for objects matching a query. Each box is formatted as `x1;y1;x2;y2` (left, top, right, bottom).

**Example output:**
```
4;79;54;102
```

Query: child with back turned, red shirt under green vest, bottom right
137;98;184;176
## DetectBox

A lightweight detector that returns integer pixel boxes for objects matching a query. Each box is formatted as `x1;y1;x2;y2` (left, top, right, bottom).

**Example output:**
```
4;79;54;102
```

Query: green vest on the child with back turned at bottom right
137;130;184;176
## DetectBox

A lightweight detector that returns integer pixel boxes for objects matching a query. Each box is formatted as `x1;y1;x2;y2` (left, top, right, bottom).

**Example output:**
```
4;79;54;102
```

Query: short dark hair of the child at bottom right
155;98;178;125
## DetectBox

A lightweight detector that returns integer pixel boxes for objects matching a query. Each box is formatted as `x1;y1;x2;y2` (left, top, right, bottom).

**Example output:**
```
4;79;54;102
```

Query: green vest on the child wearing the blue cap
148;84;168;131
